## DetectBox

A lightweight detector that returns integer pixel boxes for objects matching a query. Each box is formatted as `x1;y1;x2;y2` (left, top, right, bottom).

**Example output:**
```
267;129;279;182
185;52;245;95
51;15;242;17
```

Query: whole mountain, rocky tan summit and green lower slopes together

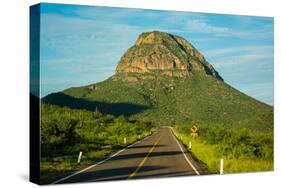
42;31;273;130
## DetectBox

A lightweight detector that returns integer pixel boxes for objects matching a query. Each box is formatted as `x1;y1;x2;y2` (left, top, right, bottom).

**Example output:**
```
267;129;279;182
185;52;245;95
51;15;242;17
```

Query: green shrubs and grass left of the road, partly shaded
41;104;154;183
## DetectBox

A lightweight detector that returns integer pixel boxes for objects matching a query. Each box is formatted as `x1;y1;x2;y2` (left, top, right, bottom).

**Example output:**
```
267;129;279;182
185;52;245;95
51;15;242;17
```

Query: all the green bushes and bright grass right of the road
174;125;273;173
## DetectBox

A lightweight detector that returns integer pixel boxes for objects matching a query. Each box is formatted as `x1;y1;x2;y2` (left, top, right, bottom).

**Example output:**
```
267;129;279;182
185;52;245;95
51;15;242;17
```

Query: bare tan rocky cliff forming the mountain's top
116;31;223;81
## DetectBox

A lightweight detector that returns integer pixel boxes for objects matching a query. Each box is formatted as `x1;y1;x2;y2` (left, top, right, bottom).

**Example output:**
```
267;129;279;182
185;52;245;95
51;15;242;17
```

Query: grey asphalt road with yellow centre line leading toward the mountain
54;128;208;183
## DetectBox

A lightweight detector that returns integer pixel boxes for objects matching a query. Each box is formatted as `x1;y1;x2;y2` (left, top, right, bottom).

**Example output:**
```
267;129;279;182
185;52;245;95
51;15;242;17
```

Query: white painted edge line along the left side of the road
49;132;156;185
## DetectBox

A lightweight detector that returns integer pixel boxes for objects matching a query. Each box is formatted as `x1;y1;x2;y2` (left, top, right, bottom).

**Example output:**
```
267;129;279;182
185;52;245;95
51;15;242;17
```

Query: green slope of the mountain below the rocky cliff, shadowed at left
43;73;273;130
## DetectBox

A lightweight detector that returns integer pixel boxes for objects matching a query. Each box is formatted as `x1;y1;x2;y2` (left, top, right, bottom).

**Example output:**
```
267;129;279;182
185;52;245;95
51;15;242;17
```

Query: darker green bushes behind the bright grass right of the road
176;125;273;160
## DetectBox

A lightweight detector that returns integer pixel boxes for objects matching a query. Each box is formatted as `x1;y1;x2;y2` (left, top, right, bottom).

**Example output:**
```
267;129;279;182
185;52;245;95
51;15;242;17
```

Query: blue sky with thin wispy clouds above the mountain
40;4;274;104
